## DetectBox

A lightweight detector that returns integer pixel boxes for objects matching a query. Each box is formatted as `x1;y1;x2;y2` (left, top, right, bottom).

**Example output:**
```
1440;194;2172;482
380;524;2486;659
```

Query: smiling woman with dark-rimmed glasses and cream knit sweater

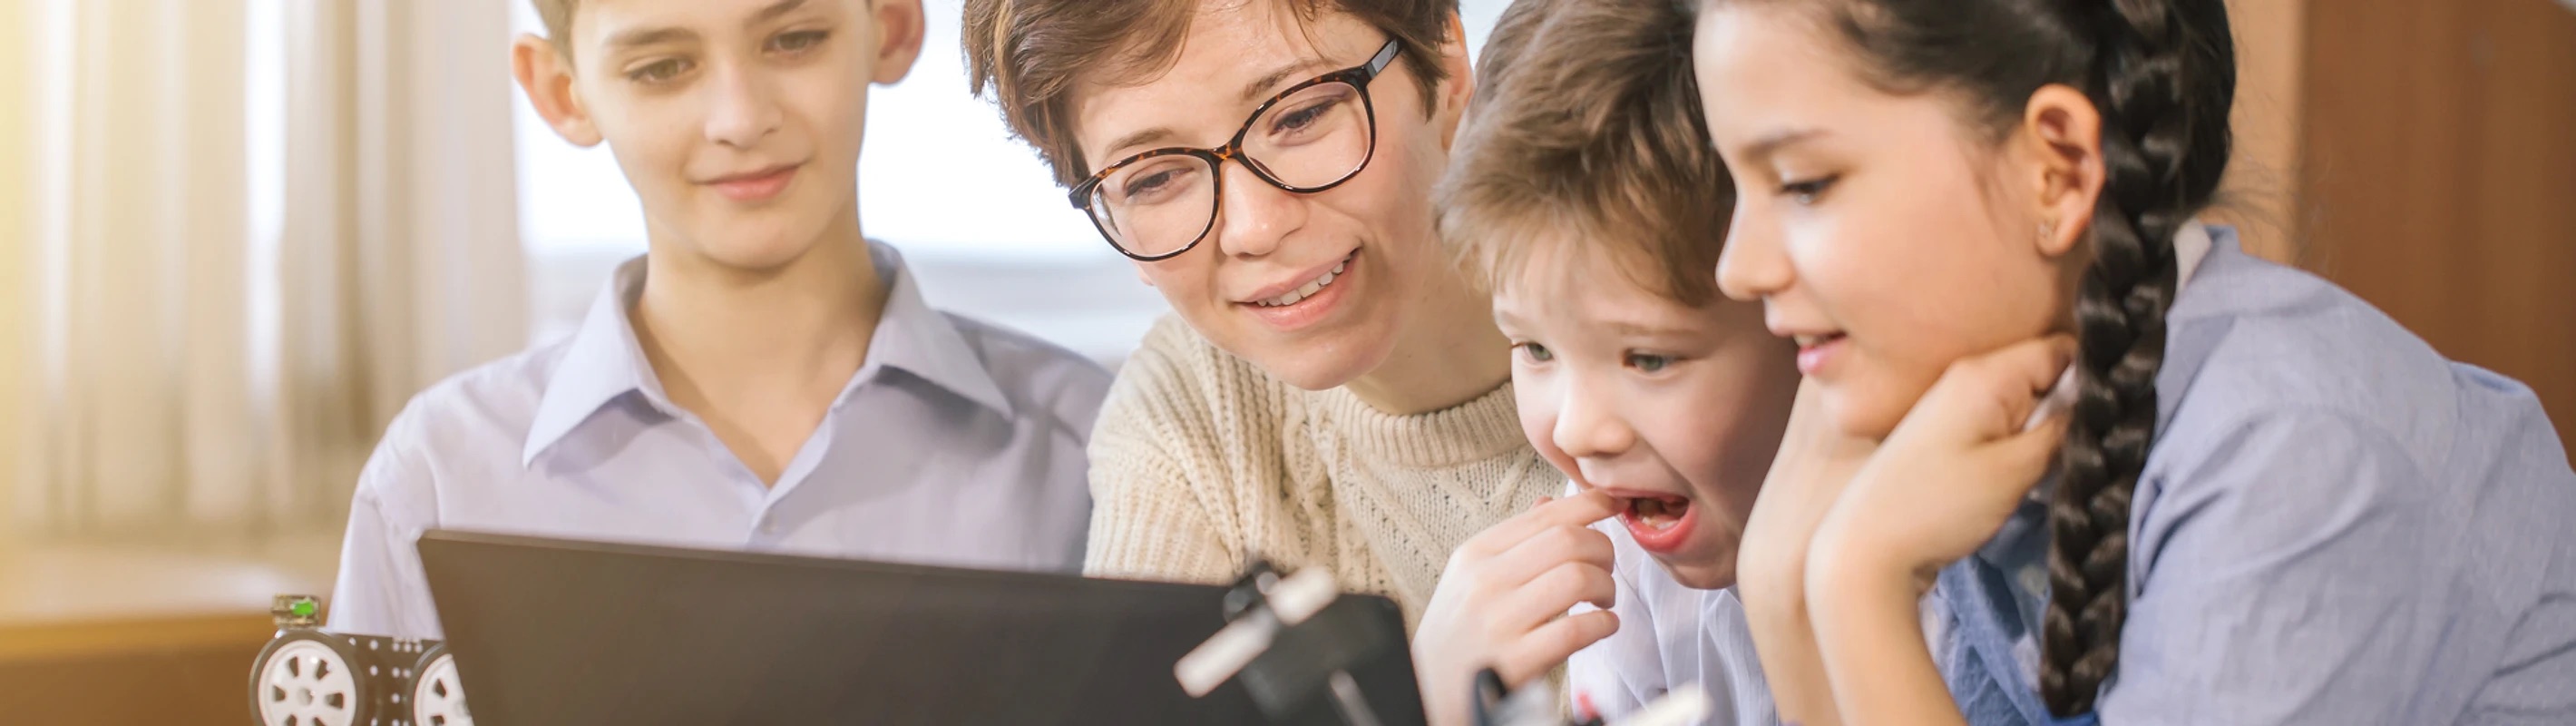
963;0;1564;635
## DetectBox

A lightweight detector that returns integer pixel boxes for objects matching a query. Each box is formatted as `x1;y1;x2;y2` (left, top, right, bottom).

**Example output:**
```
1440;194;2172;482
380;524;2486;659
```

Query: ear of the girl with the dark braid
2015;85;2107;258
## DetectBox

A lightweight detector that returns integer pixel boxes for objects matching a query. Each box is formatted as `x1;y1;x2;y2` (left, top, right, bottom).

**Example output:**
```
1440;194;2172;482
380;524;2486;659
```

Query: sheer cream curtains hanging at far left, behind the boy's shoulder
0;0;525;538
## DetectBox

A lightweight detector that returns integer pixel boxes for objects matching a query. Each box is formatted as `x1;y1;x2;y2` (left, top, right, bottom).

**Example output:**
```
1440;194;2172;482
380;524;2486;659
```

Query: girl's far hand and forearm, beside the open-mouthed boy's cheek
1736;381;1876;723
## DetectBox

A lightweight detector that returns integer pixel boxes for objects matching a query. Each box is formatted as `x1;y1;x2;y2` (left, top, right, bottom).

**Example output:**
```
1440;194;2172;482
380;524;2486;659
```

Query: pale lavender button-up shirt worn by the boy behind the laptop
330;245;1110;639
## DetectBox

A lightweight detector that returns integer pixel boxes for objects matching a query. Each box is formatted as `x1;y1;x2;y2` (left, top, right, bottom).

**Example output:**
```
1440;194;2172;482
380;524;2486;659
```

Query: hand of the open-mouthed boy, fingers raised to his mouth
1414;489;1618;726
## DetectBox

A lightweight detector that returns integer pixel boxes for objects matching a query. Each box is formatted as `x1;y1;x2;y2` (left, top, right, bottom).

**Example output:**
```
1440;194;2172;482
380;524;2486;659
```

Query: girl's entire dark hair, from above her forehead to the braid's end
1761;0;2236;716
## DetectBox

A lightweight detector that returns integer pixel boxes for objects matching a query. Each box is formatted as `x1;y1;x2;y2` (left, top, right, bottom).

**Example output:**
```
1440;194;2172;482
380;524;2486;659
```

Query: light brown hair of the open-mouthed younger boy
1438;0;1736;307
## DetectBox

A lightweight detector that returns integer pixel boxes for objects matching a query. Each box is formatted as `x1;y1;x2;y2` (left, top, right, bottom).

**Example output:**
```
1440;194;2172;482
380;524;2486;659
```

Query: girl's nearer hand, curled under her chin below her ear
1813;335;2076;594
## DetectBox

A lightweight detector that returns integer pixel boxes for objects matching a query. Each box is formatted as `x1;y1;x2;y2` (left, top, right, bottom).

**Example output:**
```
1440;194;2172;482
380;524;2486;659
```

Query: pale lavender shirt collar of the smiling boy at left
521;240;1012;466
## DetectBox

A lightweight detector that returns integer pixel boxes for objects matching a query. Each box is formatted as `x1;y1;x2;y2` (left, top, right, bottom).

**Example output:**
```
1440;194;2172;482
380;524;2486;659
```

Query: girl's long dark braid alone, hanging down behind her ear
2040;0;2236;716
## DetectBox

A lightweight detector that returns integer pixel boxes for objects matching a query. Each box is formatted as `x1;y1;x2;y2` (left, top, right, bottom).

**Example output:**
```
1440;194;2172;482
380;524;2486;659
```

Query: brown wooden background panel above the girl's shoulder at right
2279;0;2576;448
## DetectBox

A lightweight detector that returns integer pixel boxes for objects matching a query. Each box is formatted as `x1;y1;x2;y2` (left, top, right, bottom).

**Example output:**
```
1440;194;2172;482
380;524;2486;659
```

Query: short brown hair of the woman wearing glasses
963;0;1458;188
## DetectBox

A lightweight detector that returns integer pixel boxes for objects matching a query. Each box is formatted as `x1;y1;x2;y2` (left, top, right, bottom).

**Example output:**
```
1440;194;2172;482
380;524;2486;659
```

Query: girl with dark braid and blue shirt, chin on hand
1693;0;2576;723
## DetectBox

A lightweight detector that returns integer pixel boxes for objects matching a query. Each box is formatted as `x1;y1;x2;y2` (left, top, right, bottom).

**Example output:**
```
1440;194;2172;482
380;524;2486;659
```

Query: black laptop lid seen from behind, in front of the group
420;530;1422;726
